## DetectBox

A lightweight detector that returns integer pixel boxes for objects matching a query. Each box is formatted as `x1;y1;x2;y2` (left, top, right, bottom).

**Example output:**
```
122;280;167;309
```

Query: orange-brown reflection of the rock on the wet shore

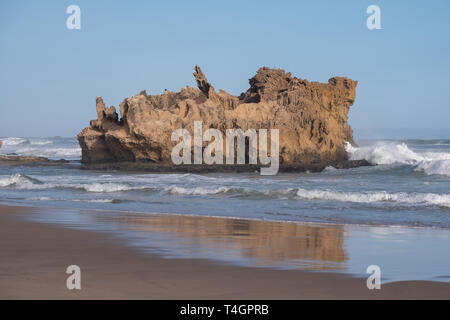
113;215;348;269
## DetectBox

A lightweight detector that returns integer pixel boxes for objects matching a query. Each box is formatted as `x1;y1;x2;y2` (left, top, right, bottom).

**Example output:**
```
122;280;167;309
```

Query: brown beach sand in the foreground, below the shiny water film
0;205;450;299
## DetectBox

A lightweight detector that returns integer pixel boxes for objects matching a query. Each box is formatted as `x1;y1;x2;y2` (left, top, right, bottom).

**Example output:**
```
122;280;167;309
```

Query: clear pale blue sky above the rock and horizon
0;0;450;138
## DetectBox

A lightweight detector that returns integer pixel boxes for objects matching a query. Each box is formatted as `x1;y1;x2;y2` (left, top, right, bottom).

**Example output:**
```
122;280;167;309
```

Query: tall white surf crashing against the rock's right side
346;142;450;176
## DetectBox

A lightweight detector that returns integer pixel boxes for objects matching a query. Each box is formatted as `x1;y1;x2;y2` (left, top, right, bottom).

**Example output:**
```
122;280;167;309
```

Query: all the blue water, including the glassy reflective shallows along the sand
0;137;450;283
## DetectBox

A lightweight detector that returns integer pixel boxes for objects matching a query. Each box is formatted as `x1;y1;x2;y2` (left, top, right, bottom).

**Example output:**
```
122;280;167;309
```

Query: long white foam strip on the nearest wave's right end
297;188;450;207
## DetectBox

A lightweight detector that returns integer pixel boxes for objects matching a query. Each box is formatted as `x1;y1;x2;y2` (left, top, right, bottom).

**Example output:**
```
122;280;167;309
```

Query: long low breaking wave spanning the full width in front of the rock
0;174;450;207
